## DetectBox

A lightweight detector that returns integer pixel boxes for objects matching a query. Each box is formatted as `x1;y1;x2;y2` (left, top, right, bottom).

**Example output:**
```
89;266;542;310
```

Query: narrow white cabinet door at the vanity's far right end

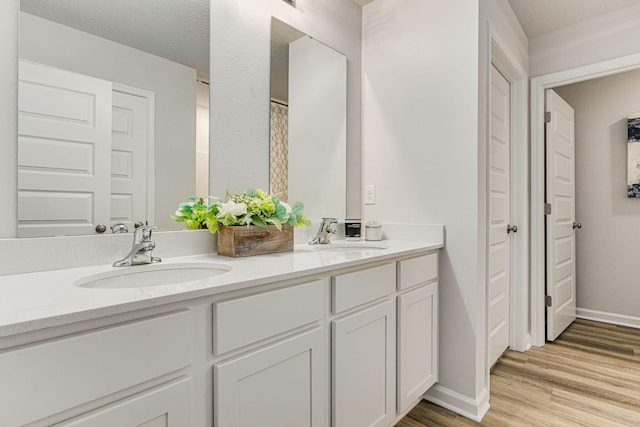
398;283;438;413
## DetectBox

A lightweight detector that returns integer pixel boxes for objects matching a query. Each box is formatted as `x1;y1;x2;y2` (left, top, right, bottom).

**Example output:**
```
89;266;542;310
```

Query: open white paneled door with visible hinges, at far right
546;90;576;341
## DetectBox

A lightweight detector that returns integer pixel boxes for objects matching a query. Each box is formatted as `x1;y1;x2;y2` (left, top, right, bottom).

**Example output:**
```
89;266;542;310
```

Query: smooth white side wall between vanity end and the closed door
362;0;486;418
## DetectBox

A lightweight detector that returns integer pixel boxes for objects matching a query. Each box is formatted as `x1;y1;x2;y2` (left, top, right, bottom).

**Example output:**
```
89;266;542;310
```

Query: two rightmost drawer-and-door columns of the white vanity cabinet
331;251;438;427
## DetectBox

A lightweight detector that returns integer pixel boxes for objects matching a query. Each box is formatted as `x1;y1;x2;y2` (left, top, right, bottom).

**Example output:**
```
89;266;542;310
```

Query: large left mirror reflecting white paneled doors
18;0;209;237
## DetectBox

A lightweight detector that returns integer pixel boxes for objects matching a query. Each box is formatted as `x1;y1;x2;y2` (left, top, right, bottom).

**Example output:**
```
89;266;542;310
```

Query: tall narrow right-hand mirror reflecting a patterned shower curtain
269;18;347;220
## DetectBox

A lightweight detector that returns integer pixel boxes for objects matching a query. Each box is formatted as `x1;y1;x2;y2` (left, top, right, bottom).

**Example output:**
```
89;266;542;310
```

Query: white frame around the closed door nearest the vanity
485;28;529;362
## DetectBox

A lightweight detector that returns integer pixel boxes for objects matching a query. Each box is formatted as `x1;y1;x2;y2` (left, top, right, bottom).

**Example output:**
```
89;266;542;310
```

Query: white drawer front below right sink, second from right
331;263;396;314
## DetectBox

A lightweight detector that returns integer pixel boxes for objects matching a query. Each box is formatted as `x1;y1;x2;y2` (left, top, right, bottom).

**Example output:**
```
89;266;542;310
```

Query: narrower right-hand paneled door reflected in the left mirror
111;90;153;230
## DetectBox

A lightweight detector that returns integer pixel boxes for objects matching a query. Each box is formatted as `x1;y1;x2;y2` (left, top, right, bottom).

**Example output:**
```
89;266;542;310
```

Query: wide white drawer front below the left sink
0;311;193;426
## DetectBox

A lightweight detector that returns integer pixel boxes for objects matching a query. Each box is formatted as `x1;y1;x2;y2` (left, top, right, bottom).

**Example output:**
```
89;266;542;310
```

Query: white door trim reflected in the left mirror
111;82;156;224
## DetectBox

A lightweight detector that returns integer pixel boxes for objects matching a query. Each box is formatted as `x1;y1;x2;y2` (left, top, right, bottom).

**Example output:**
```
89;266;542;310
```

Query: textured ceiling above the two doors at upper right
509;0;640;37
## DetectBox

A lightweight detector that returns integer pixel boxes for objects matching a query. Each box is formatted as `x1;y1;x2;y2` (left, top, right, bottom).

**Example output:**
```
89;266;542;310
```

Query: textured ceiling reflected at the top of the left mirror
20;0;209;80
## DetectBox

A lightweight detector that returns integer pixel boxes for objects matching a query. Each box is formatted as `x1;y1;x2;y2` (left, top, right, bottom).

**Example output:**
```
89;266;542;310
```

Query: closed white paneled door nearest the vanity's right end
488;66;517;366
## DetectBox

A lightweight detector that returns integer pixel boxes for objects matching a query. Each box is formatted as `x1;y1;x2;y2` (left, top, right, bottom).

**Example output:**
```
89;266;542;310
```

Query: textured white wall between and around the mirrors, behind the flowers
210;0;362;218
